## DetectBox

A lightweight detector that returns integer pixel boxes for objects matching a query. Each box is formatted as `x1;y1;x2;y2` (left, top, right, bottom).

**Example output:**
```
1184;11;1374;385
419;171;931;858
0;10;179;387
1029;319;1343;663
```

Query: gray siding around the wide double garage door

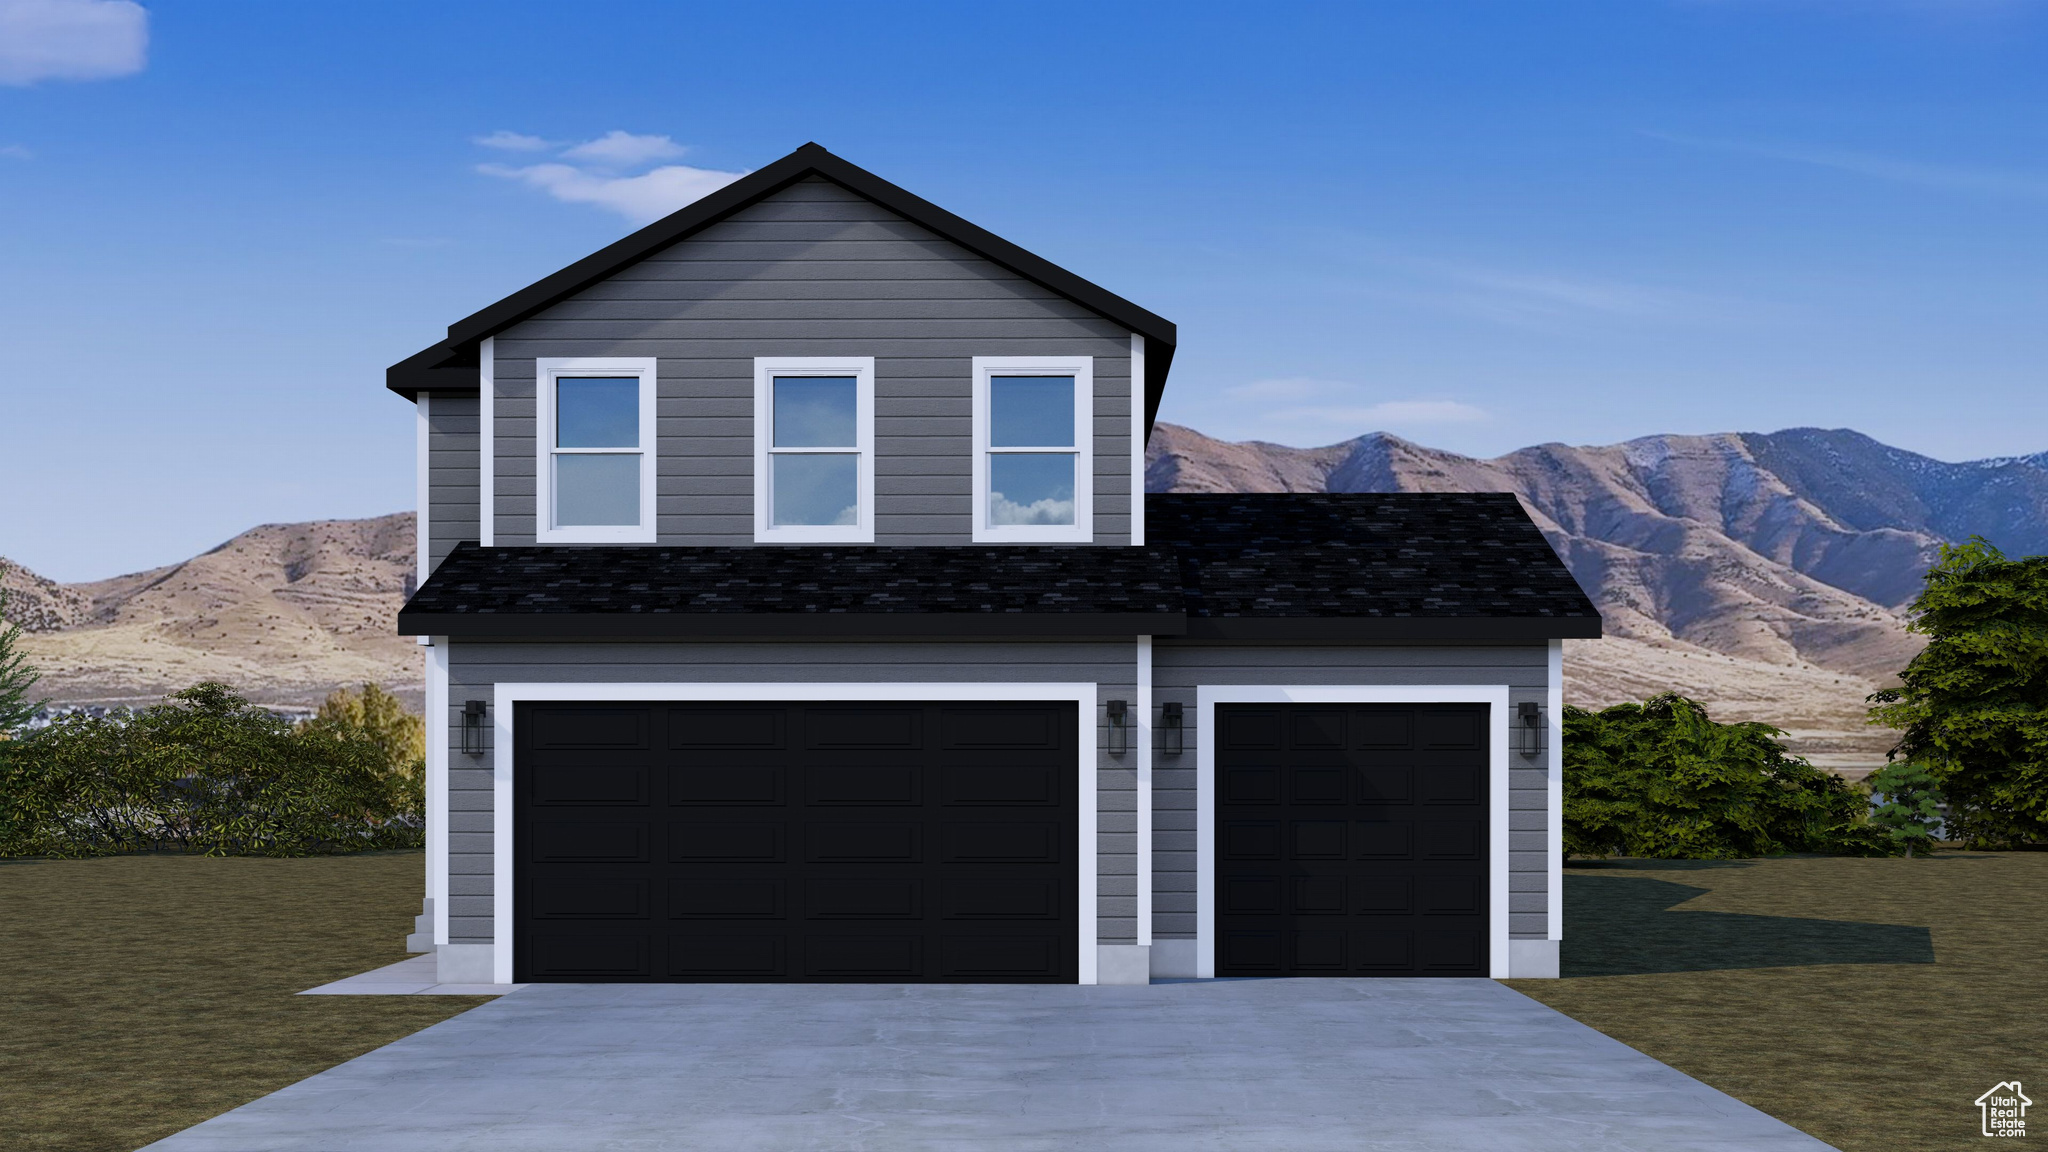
446;642;1137;943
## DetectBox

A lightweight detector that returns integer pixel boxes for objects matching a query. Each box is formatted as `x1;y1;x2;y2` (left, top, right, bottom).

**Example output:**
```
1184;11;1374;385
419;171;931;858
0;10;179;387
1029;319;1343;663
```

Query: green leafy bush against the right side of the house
1565;693;1896;859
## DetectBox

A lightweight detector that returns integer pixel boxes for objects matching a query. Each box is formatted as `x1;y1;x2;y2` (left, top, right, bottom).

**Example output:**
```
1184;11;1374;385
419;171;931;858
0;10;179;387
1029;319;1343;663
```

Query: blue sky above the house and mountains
0;0;2048;580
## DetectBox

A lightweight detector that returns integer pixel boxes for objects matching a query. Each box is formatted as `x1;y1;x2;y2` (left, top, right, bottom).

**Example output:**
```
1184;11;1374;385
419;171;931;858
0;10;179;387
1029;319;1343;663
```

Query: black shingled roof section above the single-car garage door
1145;492;1599;640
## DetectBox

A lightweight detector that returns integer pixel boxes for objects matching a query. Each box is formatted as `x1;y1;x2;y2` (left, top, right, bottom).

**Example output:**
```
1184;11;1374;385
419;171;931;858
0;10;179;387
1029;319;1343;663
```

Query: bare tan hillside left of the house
0;512;422;705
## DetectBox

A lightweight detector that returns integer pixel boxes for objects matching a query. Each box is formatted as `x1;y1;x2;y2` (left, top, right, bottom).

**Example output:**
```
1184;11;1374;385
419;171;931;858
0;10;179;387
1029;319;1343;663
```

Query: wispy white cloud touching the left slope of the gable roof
477;131;745;223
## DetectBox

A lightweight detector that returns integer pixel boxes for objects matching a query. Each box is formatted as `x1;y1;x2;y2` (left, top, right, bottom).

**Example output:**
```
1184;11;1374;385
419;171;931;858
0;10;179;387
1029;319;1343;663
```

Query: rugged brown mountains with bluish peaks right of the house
1147;424;2048;769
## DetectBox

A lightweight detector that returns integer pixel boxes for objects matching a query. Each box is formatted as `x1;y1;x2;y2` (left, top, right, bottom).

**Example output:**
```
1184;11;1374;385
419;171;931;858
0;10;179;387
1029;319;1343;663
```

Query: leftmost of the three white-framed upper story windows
535;357;655;543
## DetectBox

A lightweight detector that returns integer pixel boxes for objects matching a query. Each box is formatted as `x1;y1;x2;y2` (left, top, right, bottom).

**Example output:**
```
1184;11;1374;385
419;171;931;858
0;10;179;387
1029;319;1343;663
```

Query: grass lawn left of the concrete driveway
0;853;481;1152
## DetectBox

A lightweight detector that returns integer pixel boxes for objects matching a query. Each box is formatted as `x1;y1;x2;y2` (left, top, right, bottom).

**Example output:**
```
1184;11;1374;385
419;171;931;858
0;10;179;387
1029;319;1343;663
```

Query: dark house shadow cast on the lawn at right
1563;861;1933;976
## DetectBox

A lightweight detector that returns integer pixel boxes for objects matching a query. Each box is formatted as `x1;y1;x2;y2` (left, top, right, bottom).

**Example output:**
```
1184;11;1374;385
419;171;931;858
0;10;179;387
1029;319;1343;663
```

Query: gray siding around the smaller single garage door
1153;640;1550;939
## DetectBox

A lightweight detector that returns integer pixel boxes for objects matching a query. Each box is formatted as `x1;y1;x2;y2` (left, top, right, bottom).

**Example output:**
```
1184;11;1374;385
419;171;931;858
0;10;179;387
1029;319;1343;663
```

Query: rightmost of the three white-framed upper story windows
975;357;1096;543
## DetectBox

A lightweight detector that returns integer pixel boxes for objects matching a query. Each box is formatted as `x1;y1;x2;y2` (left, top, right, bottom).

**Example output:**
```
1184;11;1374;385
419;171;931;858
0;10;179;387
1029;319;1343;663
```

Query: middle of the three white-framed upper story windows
754;357;874;543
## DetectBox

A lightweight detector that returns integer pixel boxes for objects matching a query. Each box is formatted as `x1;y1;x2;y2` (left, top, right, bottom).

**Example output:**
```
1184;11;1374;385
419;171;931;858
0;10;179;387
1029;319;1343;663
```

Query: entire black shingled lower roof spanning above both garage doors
399;492;1599;644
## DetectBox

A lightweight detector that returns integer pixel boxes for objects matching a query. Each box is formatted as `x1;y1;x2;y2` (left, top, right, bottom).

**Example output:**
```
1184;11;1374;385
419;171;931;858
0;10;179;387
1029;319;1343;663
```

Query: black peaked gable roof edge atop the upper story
385;143;1180;430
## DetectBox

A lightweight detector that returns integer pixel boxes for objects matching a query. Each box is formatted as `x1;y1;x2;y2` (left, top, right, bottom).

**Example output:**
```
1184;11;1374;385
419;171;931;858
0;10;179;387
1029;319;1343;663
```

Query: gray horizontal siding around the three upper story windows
494;178;1130;545
